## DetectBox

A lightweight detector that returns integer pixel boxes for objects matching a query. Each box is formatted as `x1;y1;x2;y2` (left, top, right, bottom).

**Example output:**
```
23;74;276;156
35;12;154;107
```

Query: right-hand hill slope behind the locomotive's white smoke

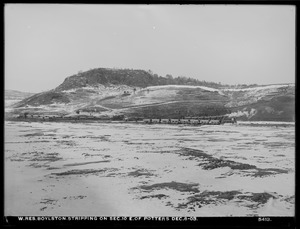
227;85;295;121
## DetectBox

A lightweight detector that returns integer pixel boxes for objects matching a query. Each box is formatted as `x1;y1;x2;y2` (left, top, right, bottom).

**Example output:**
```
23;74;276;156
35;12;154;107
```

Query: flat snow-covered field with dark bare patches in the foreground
4;122;295;217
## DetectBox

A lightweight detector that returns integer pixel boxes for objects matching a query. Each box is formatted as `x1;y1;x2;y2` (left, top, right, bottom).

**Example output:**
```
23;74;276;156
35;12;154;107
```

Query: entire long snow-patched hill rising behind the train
7;68;295;121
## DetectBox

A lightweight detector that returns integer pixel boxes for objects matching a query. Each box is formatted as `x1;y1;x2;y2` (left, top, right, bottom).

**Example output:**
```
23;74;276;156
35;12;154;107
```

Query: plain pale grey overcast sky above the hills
4;4;295;92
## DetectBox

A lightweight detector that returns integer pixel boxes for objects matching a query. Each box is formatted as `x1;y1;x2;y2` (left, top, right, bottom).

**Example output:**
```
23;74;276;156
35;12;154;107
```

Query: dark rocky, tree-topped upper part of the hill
11;68;229;107
